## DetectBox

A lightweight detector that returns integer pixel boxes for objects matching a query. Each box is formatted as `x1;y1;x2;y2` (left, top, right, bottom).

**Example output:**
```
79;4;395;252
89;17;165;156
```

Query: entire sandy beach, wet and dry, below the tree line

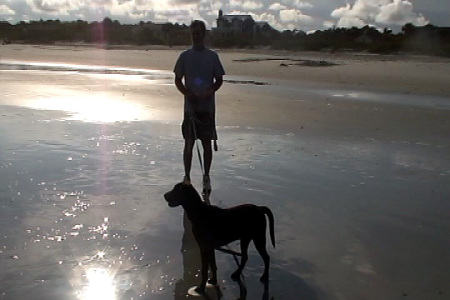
0;45;450;299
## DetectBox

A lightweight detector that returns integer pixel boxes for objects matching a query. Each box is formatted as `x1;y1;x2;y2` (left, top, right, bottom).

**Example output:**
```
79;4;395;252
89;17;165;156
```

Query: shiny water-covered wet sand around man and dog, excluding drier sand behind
0;63;450;299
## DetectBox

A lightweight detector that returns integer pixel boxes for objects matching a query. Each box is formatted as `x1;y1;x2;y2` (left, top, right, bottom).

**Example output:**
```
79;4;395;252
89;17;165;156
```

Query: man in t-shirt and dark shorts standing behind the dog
174;20;225;196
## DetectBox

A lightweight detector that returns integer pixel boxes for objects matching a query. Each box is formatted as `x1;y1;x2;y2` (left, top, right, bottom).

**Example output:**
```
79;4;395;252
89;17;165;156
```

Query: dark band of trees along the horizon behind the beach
0;18;450;56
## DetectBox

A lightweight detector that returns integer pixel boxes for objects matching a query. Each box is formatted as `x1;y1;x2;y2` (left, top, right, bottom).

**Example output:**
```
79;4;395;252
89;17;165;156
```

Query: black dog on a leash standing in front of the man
164;183;275;293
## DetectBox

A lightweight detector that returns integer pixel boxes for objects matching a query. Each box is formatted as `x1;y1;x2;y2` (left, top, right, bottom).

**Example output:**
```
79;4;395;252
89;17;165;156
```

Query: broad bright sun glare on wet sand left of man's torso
0;61;179;123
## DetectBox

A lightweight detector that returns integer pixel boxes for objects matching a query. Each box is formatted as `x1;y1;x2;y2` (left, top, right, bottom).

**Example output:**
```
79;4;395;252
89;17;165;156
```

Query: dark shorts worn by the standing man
181;112;217;141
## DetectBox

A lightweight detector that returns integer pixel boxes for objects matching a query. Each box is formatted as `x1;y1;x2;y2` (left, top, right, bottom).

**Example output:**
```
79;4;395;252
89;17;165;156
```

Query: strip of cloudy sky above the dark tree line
0;0;450;32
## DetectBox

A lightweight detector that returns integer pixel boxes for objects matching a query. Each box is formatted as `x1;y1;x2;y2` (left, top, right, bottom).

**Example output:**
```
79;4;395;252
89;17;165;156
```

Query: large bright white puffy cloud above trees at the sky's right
331;0;428;27
